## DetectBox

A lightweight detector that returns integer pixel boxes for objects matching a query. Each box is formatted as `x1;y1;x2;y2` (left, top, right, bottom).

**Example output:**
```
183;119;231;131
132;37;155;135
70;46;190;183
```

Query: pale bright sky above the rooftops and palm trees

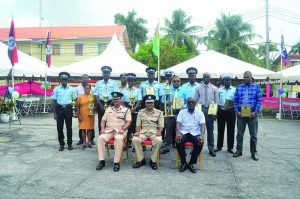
0;0;300;49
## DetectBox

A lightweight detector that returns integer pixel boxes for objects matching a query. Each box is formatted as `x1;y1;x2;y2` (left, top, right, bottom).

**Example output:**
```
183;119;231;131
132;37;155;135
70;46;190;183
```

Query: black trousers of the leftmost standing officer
55;105;73;146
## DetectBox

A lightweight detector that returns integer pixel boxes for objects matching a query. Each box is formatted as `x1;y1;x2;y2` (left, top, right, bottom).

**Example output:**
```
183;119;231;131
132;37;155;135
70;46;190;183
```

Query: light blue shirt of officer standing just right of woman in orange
94;79;119;100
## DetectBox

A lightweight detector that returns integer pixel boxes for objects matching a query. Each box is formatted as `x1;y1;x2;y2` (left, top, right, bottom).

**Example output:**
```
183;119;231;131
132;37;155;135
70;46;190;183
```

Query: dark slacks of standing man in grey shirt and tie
202;106;216;151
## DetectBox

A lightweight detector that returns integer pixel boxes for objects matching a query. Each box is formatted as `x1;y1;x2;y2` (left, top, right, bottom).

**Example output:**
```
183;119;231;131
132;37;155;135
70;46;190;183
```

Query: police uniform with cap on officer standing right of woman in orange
94;66;119;132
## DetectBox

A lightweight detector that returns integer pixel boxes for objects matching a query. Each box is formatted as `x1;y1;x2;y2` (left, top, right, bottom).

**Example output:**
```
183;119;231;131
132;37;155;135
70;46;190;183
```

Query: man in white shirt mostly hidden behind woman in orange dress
75;74;95;145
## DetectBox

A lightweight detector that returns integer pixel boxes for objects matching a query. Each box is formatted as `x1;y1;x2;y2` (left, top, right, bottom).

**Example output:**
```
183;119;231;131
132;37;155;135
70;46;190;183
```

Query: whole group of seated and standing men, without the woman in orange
52;66;262;173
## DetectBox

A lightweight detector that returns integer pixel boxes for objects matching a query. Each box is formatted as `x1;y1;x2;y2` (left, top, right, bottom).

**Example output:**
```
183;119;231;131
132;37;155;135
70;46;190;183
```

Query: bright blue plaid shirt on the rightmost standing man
234;83;262;113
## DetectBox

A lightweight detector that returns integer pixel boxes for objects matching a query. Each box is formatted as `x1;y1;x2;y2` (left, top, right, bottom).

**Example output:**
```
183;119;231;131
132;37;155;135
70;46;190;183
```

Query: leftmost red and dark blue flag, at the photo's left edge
7;20;18;66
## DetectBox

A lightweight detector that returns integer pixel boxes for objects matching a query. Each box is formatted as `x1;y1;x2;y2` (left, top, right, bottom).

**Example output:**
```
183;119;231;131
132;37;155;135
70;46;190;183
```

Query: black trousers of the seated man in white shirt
177;133;203;164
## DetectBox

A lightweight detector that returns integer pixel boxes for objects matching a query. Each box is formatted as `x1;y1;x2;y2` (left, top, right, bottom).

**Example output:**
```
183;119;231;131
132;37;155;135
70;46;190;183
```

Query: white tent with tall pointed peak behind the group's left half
60;34;147;77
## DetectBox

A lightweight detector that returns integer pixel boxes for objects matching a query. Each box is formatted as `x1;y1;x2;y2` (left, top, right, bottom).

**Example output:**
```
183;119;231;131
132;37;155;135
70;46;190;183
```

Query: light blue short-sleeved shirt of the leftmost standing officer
51;85;76;106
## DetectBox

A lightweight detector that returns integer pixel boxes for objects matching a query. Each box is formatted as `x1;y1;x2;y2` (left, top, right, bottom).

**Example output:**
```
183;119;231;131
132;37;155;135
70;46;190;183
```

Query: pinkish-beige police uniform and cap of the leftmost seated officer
97;92;131;166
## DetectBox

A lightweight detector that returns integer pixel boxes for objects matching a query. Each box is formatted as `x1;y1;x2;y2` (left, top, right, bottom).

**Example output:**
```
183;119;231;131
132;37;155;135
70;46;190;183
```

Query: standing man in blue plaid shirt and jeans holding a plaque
233;71;262;161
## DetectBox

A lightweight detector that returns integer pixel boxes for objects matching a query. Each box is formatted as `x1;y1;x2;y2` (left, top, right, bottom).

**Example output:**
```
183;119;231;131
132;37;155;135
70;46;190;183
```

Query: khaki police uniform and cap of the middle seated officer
132;95;164;166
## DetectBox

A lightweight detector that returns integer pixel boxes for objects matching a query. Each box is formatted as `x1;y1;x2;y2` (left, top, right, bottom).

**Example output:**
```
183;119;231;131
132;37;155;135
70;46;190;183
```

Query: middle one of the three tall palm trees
161;9;202;52
